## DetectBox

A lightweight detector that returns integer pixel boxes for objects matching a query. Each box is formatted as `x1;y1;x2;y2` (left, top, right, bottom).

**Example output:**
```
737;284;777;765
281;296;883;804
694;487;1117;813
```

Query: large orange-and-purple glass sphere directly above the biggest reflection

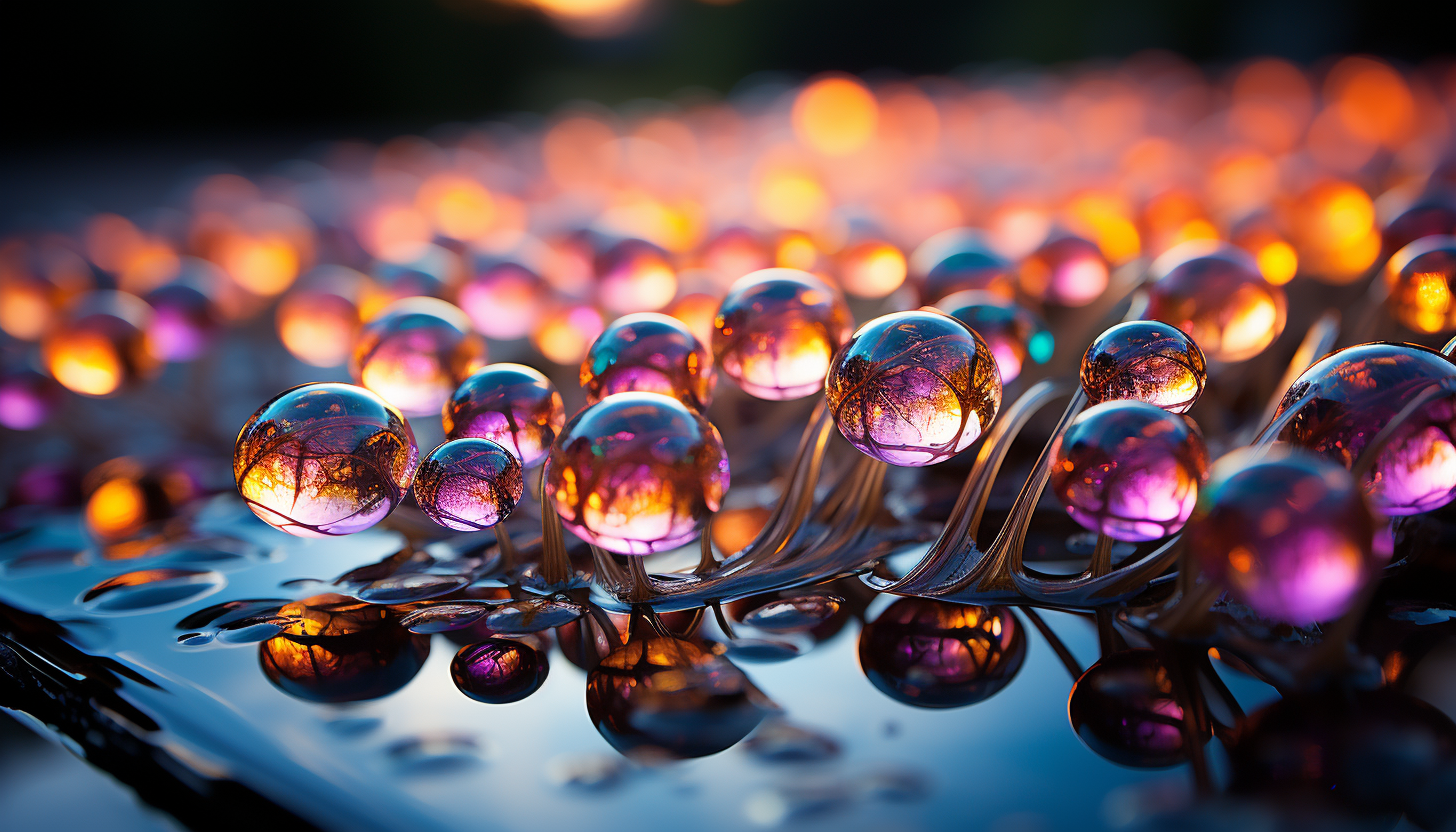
546;393;728;555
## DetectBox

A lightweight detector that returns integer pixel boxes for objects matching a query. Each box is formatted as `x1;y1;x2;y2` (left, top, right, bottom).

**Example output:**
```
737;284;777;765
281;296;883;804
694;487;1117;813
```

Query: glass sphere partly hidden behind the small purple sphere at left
441;364;566;468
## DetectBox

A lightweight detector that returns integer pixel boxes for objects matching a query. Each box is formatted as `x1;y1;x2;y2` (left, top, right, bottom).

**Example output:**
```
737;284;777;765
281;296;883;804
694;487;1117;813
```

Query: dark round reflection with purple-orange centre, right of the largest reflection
859;597;1026;708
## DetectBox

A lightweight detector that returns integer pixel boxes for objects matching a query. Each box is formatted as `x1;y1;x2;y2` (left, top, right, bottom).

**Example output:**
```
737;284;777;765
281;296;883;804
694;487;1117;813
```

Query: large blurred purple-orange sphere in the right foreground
1187;449;1377;625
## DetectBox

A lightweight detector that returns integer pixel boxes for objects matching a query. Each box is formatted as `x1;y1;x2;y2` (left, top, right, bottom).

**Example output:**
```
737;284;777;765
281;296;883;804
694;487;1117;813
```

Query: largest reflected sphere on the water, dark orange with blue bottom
587;638;778;762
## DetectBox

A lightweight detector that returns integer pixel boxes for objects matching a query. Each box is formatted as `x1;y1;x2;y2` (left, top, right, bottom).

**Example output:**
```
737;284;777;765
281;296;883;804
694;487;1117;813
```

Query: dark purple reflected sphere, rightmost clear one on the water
1067;650;1188;768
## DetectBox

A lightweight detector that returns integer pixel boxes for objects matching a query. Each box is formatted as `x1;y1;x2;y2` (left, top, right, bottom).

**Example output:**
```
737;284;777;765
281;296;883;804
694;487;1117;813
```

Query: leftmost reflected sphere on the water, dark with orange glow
258;594;430;702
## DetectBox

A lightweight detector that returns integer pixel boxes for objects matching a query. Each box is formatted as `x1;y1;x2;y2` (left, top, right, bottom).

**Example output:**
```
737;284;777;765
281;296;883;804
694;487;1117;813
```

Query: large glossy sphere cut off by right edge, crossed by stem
1274;344;1456;516
